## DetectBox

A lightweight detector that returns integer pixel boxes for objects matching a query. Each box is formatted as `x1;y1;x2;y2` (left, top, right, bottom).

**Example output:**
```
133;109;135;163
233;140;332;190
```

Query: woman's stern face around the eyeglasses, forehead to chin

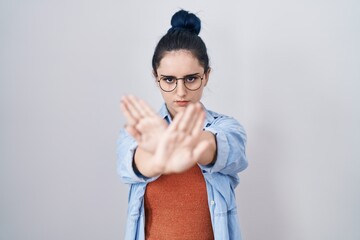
156;50;209;117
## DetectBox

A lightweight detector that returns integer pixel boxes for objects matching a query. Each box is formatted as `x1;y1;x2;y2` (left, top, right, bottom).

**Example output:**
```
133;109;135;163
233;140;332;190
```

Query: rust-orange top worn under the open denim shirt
145;165;214;240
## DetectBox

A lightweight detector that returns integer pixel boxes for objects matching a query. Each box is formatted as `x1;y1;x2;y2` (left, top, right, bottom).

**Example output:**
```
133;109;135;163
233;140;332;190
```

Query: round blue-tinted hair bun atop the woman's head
169;10;201;35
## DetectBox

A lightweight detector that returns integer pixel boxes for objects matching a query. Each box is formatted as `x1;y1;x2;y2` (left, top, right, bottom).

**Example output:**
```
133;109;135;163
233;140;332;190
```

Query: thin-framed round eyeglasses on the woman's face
158;74;205;92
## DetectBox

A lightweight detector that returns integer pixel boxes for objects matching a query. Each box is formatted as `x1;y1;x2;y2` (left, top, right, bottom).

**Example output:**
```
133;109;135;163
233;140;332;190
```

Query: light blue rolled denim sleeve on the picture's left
116;129;157;184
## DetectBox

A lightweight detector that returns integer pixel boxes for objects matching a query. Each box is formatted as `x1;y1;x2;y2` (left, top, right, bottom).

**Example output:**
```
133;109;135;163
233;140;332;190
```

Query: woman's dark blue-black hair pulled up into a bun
152;10;209;75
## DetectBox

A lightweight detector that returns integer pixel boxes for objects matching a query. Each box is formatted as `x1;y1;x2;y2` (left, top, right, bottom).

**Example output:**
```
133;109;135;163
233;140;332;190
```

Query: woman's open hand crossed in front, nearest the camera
153;103;209;174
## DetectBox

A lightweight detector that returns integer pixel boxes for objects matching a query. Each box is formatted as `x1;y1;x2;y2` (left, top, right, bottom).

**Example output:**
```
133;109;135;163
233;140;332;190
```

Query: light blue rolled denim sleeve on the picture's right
200;116;248;175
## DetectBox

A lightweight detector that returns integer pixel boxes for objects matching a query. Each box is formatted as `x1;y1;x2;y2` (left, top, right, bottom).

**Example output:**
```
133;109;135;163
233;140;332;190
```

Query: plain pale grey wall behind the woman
0;0;360;240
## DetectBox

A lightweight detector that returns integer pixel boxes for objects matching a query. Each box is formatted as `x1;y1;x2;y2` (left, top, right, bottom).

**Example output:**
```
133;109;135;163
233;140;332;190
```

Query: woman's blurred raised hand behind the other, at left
120;96;167;153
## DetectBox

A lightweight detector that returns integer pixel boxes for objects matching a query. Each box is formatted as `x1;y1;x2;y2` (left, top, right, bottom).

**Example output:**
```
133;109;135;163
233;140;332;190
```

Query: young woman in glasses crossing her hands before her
117;10;247;240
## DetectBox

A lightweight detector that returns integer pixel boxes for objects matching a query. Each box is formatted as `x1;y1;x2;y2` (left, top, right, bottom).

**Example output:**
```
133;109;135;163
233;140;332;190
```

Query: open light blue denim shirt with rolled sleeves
117;104;248;240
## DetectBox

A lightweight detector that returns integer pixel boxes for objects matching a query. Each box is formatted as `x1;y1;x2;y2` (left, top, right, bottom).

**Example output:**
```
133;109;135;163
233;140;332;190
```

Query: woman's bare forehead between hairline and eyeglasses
157;50;204;76
